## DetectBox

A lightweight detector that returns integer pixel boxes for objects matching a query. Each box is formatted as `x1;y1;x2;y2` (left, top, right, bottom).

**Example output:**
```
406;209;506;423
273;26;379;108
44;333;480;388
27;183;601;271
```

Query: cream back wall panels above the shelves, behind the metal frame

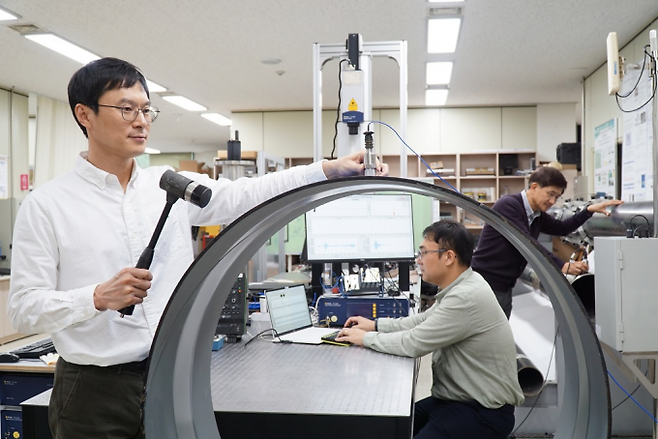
232;103;576;161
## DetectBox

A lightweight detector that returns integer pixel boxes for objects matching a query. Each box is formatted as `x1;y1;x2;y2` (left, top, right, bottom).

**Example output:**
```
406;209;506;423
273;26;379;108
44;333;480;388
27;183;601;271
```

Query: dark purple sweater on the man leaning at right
471;193;592;292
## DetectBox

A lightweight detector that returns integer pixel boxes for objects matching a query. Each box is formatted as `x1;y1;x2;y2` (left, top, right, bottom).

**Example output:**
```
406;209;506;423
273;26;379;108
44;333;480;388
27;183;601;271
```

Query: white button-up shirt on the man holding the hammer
8;153;326;366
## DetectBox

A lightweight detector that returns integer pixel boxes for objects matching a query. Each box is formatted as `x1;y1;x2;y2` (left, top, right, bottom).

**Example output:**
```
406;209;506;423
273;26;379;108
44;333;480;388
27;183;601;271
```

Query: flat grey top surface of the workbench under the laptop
211;339;415;416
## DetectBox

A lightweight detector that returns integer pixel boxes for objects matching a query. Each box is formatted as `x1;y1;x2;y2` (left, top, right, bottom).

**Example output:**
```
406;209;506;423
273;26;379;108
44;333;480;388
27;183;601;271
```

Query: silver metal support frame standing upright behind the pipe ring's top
313;41;408;177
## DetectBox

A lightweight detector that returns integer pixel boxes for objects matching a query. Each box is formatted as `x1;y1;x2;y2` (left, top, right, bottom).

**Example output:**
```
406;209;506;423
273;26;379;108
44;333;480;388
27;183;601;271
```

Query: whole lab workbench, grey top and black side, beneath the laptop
22;337;417;439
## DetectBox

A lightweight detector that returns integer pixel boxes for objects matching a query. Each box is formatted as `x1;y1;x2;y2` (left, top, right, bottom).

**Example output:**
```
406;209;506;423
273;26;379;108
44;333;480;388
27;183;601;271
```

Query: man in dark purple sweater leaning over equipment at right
472;167;622;318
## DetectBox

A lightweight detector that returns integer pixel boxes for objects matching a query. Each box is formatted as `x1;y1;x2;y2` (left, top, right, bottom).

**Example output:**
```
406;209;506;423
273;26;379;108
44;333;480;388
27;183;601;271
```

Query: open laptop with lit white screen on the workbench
265;285;336;344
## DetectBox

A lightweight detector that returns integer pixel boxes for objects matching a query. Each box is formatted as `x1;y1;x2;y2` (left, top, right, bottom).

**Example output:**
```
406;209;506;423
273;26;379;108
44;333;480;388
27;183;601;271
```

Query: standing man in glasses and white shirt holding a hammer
8;58;388;439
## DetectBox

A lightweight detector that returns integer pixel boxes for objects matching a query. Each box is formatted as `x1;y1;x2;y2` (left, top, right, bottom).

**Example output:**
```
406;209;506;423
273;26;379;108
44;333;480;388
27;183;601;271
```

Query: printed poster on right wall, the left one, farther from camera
594;119;617;197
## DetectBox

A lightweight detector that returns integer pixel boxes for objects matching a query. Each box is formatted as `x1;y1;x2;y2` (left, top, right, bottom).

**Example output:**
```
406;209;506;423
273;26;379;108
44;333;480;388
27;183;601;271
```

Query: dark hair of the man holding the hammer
68;58;150;138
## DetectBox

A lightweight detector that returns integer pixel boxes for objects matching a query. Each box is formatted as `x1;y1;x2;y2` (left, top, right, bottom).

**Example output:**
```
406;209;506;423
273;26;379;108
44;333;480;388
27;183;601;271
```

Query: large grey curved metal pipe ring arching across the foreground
144;177;610;439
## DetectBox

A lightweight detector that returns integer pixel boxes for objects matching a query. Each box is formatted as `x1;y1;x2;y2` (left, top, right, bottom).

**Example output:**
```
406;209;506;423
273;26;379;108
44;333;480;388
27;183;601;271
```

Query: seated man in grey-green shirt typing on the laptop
336;220;523;439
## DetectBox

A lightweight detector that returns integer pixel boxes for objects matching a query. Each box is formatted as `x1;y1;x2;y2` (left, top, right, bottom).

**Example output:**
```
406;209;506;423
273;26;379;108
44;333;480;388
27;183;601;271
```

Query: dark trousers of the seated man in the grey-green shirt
414;396;514;439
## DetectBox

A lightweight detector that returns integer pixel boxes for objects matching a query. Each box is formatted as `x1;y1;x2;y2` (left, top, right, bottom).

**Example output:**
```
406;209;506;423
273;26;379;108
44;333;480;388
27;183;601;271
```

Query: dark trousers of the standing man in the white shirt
48;357;146;439
